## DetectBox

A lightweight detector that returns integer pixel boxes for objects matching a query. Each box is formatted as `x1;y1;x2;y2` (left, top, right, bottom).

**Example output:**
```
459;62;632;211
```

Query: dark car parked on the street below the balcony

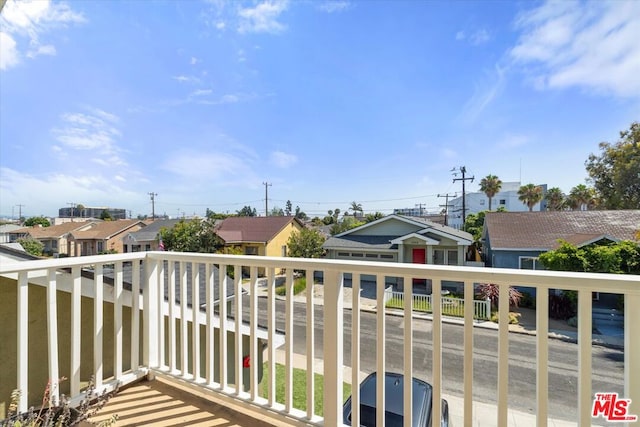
343;372;449;427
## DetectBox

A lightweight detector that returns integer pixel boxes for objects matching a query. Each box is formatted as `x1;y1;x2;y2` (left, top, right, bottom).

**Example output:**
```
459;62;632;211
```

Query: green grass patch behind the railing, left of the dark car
258;363;351;416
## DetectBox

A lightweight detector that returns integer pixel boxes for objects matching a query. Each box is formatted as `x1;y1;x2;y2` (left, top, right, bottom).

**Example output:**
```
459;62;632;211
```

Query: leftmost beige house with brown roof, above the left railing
10;220;97;256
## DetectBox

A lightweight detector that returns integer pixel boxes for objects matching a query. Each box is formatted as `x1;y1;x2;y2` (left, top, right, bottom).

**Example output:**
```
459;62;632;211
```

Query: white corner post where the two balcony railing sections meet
142;257;159;368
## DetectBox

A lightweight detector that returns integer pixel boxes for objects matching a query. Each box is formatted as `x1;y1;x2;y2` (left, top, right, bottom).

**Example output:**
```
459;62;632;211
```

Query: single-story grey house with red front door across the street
323;214;476;292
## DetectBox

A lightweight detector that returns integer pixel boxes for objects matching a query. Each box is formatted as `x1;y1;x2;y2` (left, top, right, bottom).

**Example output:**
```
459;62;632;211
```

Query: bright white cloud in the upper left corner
0;0;86;70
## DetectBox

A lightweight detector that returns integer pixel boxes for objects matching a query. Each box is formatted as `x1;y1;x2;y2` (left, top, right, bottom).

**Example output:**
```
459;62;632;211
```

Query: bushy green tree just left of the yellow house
160;218;224;253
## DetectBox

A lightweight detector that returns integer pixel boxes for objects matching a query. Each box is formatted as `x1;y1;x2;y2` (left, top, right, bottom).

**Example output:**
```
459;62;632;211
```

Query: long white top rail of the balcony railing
0;251;640;295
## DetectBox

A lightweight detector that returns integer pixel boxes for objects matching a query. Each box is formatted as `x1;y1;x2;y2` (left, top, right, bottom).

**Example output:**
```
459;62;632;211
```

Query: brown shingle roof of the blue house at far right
483;210;640;251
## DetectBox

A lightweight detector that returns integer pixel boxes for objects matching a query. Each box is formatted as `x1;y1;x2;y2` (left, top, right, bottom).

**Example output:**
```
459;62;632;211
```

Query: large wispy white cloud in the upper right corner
510;0;640;97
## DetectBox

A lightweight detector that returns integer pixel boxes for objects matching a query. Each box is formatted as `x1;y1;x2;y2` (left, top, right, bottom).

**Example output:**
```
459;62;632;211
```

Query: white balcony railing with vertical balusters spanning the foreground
0;252;640;426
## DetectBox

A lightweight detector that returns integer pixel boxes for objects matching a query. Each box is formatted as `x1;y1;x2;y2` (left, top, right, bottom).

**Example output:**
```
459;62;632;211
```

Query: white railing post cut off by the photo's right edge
624;293;640;426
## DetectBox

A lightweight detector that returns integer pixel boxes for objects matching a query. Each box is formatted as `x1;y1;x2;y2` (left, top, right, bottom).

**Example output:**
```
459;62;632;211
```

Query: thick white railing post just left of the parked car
323;270;342;427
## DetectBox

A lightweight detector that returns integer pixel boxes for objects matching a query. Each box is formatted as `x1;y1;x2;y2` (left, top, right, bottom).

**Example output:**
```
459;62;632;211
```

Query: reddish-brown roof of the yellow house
216;216;304;244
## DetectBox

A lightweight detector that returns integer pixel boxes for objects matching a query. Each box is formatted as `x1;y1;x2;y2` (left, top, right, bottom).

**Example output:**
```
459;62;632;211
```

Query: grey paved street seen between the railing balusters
238;298;624;421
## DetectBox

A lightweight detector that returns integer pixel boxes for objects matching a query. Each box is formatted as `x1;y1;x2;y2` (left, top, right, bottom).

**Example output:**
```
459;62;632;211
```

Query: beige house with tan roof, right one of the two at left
69;219;145;256
